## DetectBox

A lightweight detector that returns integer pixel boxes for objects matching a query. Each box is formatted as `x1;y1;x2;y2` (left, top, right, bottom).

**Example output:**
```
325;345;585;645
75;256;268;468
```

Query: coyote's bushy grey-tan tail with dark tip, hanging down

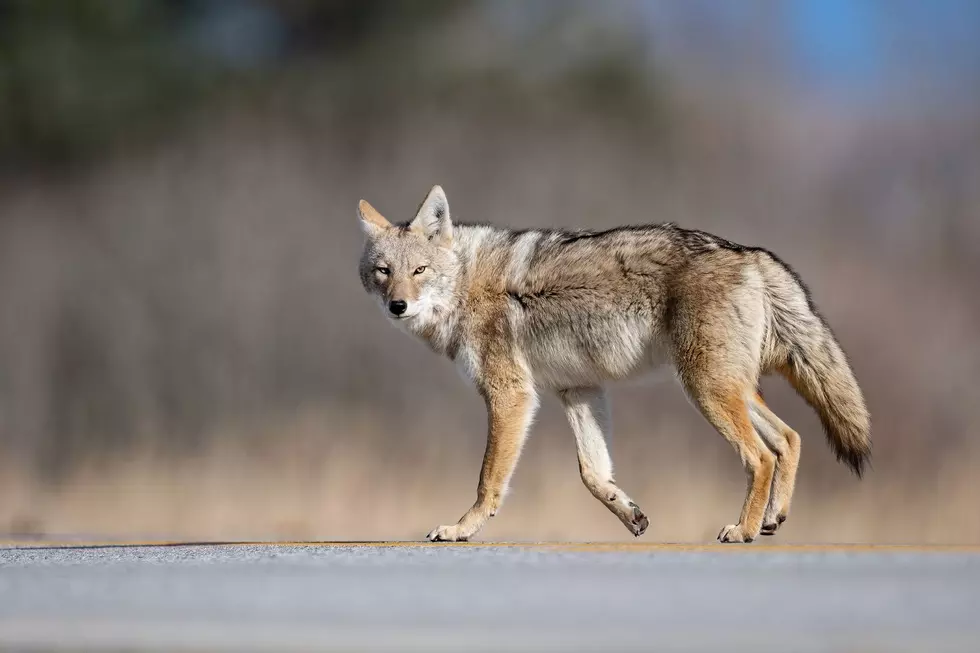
769;257;871;476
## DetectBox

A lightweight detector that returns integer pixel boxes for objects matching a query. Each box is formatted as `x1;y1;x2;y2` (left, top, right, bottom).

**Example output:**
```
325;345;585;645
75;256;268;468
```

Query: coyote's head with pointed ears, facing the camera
358;186;459;327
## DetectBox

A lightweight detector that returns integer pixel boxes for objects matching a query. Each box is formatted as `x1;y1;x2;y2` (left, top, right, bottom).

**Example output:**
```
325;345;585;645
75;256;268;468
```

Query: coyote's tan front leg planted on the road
427;384;537;542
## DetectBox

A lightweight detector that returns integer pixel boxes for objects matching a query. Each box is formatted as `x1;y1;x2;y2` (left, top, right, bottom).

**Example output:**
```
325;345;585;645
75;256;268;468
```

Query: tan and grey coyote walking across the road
358;186;871;542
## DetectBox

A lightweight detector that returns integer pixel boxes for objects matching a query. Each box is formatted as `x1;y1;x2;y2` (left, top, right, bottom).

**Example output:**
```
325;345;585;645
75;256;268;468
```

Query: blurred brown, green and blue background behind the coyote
0;0;980;543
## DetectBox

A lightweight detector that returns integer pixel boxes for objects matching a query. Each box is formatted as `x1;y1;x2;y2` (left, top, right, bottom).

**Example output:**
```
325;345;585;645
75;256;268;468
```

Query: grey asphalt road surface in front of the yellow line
0;545;980;652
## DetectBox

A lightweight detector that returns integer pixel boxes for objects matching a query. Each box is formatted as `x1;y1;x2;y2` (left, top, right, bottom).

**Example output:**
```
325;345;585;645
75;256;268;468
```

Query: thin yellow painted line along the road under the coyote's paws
0;540;980;554
